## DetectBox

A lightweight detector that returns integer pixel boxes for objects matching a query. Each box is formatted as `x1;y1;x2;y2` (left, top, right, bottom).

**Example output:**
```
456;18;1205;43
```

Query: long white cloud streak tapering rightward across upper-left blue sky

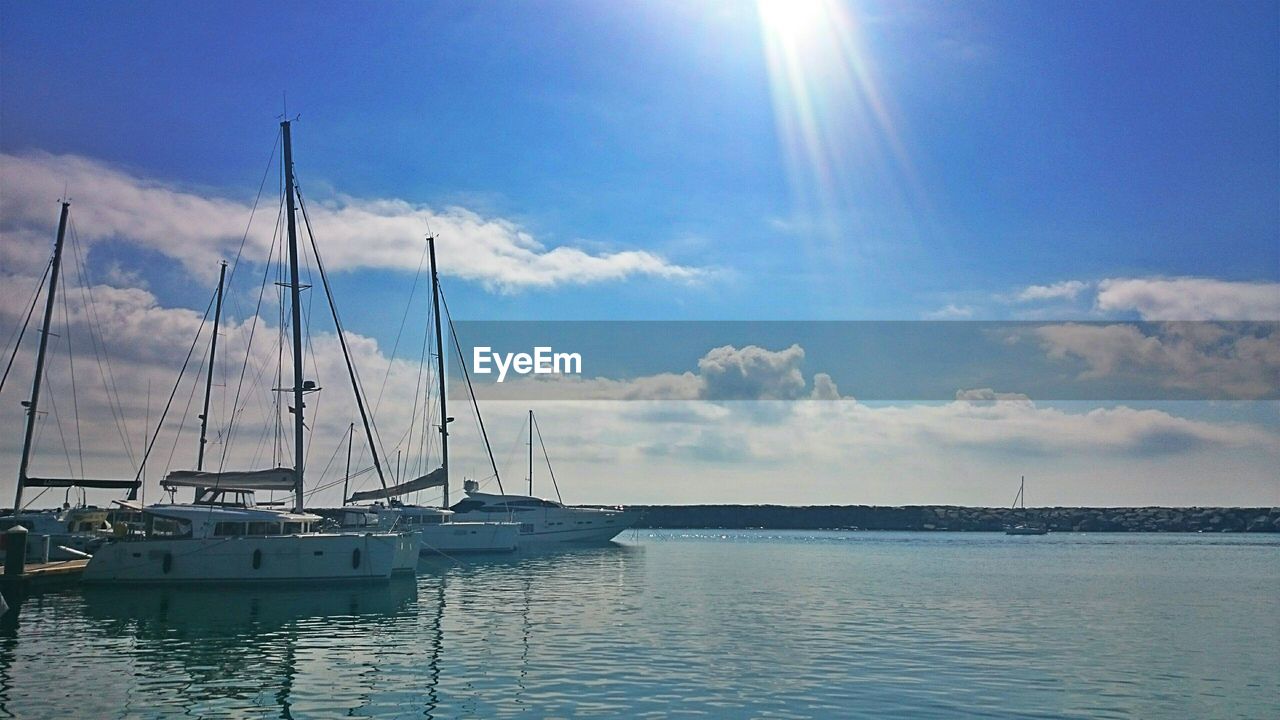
0;154;703;291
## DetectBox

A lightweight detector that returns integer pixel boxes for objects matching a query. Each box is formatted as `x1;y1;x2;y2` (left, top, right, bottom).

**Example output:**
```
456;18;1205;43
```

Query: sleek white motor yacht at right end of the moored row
452;410;640;547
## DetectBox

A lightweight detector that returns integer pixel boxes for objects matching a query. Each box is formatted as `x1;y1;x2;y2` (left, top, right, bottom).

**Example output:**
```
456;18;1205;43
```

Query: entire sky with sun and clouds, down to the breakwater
0;0;1280;506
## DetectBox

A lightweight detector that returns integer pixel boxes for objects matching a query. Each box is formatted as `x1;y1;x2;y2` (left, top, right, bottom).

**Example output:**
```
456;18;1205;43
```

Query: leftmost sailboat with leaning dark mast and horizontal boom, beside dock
0;201;138;561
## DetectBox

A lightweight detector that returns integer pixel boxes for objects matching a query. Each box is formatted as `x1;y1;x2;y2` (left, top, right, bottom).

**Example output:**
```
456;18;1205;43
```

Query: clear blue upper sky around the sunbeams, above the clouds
0;3;1280;319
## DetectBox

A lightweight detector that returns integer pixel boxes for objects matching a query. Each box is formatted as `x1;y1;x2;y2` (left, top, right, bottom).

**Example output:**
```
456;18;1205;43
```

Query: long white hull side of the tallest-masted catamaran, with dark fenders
83;534;406;584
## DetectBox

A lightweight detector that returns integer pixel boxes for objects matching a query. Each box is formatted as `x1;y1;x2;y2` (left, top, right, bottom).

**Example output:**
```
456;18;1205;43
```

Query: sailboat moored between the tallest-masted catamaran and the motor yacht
342;236;520;556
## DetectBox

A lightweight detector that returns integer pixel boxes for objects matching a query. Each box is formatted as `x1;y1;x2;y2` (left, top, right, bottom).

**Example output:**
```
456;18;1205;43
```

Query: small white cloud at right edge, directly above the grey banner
1096;278;1280;320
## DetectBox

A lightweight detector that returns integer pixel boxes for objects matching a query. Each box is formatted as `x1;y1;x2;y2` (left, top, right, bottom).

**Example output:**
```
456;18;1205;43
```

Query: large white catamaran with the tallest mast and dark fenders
84;120;416;584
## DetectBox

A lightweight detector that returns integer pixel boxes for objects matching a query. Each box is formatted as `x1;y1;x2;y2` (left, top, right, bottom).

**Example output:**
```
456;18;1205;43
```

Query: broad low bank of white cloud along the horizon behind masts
0;278;1280;503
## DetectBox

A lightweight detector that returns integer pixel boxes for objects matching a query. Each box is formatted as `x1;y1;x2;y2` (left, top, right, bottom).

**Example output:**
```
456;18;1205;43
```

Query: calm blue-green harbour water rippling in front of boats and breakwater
0;530;1280;719
